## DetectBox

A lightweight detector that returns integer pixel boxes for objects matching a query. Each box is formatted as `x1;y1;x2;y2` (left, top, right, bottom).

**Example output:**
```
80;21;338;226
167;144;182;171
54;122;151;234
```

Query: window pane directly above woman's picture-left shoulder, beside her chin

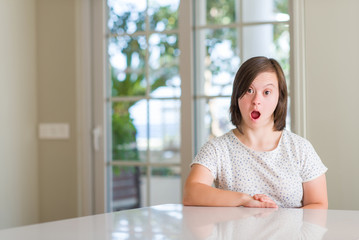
195;97;234;152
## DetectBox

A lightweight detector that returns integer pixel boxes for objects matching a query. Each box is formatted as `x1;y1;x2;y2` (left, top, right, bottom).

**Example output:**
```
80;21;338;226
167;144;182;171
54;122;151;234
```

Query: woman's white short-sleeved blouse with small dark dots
191;130;327;208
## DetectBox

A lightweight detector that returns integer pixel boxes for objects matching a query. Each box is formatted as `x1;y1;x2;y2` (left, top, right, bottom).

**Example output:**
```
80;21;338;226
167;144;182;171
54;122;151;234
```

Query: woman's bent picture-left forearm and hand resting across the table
183;164;277;207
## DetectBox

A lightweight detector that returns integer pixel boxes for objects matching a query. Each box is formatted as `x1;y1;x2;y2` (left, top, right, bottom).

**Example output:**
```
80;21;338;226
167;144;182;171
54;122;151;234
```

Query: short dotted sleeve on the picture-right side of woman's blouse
301;140;328;182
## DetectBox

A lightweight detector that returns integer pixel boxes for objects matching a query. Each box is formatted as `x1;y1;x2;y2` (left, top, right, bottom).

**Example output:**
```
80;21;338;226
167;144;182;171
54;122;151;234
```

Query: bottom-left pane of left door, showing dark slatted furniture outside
111;166;146;211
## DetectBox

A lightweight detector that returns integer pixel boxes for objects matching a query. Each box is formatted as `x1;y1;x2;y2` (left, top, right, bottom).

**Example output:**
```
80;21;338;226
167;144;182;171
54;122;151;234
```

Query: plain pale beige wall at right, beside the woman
305;0;359;210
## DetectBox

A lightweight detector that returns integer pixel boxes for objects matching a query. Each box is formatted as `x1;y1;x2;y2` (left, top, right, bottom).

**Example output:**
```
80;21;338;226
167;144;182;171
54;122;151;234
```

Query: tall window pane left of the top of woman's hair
196;28;240;96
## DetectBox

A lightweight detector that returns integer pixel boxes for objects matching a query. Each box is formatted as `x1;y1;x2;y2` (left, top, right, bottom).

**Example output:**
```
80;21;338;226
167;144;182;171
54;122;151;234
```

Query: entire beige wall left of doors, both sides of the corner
0;0;78;229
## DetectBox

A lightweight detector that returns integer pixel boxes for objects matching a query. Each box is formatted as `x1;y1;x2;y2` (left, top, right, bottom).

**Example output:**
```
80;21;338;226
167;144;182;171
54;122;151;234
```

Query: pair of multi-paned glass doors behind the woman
92;0;292;212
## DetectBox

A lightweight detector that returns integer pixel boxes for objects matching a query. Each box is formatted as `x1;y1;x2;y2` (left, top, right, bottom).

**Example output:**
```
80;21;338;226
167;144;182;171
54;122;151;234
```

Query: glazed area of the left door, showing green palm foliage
106;0;181;211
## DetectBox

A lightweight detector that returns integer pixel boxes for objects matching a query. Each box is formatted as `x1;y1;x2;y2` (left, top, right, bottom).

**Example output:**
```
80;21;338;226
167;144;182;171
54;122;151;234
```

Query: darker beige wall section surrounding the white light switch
36;0;78;222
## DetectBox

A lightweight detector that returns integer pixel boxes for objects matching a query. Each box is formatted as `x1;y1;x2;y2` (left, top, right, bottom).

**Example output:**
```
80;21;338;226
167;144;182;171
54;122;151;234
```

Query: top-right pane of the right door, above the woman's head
243;0;289;22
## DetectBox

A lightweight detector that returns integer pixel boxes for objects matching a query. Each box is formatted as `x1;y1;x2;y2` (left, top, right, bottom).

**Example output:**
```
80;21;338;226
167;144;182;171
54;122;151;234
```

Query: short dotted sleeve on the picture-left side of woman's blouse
191;142;218;179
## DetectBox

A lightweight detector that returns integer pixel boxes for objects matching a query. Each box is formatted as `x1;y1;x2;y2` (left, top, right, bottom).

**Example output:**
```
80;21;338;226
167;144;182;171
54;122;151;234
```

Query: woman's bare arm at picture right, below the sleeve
302;174;328;209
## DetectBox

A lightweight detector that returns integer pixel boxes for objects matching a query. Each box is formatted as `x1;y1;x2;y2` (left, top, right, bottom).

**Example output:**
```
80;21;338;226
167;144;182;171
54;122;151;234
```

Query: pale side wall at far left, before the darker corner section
0;0;39;229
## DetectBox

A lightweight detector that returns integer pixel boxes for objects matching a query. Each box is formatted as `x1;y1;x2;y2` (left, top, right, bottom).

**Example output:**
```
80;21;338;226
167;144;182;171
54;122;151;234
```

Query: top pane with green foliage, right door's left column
195;0;239;26
